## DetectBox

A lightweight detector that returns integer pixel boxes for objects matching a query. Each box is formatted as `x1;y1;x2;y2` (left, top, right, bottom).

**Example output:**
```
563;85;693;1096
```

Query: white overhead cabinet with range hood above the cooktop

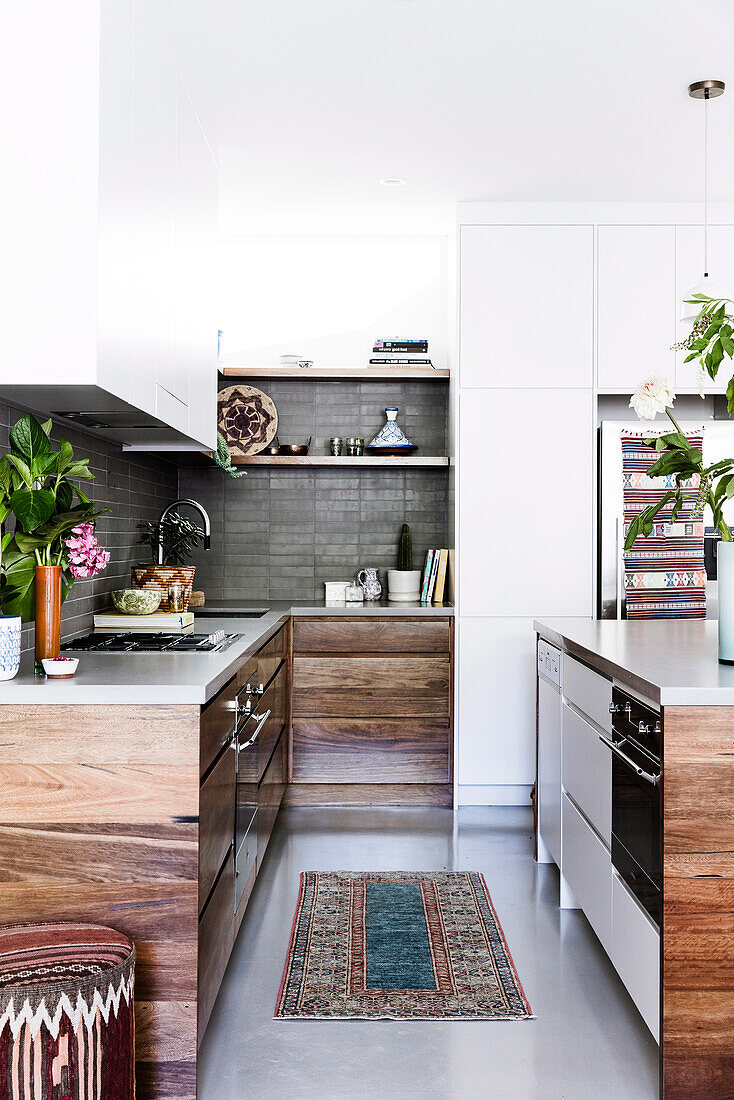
0;0;218;449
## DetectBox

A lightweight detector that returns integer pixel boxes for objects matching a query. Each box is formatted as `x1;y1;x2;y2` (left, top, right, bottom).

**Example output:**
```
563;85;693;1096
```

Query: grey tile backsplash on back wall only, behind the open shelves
179;382;449;601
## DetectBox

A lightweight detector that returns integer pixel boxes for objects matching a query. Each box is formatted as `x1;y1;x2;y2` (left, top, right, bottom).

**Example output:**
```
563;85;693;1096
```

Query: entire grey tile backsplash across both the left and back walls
0;382;449;633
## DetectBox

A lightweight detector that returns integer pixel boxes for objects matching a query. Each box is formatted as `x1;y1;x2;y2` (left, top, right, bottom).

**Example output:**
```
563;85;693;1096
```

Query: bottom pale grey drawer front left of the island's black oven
561;794;612;953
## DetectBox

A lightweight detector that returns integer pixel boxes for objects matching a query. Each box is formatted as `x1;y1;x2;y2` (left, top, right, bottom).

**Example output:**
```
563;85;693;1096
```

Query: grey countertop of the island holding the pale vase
533;618;734;706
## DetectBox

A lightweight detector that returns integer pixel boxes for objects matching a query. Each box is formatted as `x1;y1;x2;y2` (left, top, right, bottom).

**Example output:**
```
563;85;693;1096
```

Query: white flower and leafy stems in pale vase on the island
624;294;734;663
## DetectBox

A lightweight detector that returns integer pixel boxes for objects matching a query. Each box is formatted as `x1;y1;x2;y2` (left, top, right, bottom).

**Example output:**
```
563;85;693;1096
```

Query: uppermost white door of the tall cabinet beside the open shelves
460;226;594;388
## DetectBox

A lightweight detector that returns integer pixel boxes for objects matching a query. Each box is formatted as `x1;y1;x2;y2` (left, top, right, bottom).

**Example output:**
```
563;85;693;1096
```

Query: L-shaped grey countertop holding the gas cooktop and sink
0;601;453;706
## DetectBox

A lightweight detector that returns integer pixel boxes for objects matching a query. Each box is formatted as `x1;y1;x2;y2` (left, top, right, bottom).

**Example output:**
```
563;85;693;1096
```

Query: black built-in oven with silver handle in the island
602;688;662;927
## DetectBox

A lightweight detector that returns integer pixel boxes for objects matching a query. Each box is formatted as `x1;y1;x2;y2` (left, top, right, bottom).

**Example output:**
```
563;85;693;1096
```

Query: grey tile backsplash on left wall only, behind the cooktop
0;403;178;650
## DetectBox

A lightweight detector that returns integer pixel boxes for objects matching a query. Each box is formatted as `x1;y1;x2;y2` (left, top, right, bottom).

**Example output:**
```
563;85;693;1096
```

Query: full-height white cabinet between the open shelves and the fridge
457;224;594;804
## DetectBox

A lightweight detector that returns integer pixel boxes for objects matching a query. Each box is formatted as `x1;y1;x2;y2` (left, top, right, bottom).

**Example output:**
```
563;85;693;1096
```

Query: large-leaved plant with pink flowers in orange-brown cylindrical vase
0;414;110;669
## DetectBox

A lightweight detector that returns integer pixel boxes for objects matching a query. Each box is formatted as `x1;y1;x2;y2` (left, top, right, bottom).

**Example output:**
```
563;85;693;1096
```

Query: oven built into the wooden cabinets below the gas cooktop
234;684;270;911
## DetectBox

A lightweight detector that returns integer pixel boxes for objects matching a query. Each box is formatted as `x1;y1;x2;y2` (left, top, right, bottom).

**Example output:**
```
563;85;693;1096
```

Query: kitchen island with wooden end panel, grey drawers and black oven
534;619;734;1098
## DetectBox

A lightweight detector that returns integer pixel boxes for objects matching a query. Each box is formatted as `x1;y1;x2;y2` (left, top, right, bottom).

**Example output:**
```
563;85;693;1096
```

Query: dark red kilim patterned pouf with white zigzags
0;924;135;1100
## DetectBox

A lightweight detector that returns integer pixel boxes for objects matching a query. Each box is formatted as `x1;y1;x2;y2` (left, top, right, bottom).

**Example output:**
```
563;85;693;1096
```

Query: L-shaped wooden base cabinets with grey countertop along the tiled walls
0;601;452;1100
